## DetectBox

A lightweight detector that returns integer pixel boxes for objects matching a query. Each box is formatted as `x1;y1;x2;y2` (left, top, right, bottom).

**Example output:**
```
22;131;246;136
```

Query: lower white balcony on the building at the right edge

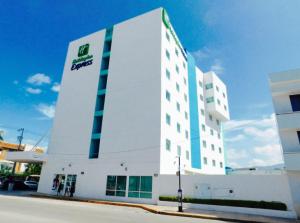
276;111;300;130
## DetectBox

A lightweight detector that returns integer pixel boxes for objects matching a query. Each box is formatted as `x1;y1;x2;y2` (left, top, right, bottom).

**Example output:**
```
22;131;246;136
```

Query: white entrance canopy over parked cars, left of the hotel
5;151;47;163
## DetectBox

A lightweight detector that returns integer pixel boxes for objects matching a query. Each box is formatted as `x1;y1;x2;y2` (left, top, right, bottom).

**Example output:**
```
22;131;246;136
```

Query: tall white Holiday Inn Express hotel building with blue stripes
38;8;229;203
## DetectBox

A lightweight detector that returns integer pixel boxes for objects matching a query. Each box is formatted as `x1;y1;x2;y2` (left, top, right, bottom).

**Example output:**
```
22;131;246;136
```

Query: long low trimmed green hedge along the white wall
159;196;287;211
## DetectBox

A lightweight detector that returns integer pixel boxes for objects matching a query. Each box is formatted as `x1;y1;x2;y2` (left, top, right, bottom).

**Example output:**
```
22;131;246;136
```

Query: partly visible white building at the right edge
269;69;300;217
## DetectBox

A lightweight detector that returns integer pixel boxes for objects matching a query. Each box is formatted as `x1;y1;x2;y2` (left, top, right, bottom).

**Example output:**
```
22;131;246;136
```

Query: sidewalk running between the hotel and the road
30;193;300;223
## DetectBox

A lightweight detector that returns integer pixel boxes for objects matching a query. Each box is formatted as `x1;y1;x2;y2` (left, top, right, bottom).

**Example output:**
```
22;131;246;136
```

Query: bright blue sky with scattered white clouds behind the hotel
0;0;300;167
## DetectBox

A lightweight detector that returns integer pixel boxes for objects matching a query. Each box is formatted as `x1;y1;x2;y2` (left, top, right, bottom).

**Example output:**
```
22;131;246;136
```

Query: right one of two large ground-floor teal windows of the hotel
128;176;152;198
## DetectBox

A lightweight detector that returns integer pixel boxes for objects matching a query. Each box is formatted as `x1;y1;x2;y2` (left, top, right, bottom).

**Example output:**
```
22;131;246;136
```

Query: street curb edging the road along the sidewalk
30;194;292;223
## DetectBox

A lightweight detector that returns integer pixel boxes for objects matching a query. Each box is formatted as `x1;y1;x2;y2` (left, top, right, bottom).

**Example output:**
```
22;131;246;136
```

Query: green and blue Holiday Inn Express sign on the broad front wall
71;43;93;70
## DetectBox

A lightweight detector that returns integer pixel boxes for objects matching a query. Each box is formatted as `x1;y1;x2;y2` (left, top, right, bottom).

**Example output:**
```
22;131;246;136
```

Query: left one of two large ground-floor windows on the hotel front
106;176;126;197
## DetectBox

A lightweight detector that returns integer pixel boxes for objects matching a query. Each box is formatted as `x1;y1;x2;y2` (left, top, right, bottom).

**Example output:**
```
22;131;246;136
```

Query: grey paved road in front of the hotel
0;194;231;223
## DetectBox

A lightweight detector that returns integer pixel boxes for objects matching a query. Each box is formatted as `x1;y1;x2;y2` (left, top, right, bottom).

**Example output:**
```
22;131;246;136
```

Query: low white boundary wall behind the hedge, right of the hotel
158;175;293;210
